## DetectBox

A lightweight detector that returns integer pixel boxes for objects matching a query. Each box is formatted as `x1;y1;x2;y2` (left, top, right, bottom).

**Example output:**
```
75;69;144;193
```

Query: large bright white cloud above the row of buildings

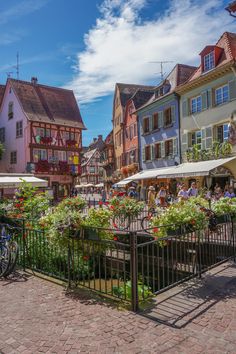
67;0;235;103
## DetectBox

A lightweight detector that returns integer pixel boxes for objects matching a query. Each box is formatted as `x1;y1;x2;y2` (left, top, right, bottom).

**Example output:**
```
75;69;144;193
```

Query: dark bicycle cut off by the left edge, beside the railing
0;225;19;277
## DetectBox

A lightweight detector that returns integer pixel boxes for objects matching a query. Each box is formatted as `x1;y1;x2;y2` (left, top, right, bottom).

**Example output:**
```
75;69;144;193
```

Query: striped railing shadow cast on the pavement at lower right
139;263;236;329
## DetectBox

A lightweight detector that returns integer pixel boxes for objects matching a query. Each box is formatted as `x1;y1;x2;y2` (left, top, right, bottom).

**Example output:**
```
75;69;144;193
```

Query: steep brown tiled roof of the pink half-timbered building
8;79;86;129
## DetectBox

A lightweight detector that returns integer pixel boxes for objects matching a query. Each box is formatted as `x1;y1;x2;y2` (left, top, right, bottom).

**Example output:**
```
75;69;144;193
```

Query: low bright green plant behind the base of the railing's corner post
112;280;153;301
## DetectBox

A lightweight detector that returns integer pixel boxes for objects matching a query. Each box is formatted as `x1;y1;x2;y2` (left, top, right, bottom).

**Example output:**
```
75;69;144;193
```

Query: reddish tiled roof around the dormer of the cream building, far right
188;32;236;82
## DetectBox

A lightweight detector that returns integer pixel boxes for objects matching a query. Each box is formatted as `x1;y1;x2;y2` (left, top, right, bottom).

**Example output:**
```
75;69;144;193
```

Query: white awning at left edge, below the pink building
0;175;48;188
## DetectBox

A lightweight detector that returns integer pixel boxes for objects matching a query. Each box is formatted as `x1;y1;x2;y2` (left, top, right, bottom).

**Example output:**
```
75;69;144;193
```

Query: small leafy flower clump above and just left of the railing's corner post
110;197;145;218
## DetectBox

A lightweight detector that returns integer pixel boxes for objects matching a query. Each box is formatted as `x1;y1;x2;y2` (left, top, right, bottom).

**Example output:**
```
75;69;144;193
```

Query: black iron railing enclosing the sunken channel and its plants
0;216;235;311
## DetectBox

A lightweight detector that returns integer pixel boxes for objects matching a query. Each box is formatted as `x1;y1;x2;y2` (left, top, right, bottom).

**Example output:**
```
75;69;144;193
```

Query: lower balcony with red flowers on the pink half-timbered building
26;160;81;176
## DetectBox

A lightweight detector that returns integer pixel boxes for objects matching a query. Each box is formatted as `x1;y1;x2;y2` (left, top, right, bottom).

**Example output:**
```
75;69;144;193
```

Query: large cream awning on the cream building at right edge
157;157;236;178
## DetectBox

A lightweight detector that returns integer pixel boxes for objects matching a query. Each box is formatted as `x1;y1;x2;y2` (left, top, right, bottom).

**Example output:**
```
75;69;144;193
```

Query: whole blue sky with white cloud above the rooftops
0;0;236;145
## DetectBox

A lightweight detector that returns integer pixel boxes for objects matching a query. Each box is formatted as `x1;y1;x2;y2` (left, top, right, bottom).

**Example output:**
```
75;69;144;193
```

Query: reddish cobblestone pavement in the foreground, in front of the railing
0;264;236;354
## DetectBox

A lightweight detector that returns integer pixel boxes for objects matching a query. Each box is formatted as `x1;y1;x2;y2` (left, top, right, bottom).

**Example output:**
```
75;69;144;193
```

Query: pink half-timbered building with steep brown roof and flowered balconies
0;78;86;198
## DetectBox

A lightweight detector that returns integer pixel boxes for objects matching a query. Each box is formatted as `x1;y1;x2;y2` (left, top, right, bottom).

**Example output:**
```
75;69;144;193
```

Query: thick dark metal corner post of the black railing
130;232;138;312
